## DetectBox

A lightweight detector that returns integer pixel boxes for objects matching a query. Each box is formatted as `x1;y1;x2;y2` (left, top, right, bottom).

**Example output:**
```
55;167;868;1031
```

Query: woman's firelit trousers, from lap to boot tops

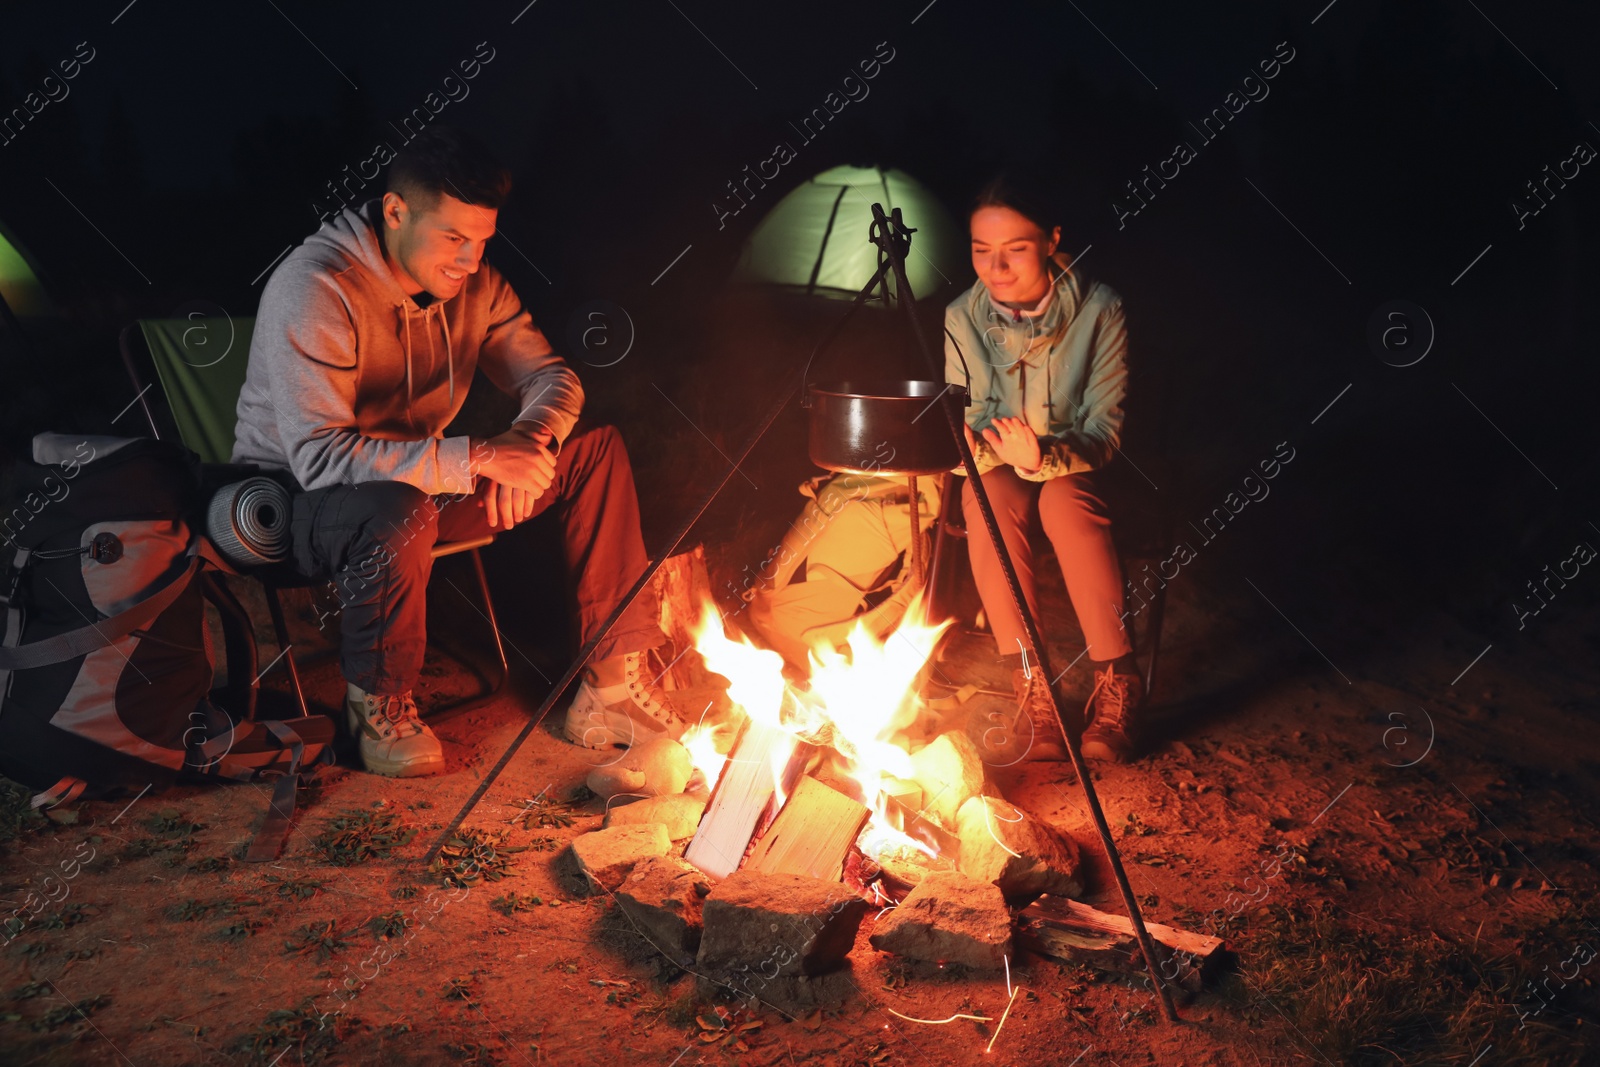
962;467;1133;661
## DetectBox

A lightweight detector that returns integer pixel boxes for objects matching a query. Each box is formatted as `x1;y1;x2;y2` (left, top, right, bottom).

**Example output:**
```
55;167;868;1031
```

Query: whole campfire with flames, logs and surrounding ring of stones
550;579;1221;1011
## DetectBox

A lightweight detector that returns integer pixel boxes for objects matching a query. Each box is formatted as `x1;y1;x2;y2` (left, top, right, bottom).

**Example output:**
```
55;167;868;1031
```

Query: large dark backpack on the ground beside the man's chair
0;434;333;859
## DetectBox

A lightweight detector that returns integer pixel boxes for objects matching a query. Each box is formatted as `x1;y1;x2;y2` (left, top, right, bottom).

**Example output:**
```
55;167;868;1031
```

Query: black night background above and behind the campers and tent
0;0;1600;633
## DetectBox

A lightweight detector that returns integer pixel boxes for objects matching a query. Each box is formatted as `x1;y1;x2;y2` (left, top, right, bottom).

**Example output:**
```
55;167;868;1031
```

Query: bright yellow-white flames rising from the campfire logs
685;593;950;856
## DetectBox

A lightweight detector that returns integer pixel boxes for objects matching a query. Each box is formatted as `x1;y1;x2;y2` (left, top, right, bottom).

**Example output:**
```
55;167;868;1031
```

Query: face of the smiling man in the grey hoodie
384;192;499;301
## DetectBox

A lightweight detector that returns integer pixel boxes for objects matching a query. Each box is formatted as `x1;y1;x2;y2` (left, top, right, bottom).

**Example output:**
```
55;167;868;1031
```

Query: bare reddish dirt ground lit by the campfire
0;511;1600;1067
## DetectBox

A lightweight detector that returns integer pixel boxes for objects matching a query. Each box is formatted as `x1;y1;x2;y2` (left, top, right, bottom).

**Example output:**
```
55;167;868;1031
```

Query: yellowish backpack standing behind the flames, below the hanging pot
738;474;939;670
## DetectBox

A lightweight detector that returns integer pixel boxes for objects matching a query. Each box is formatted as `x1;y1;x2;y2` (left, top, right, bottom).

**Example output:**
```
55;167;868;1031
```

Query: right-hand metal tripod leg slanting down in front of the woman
872;203;1178;1022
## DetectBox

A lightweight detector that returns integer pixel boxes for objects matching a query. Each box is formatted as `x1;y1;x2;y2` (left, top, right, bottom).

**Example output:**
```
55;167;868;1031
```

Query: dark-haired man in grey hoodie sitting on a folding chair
234;125;683;776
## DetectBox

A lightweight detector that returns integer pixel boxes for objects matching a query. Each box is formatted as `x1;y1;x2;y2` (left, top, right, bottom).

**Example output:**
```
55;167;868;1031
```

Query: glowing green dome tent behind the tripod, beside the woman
733;166;966;299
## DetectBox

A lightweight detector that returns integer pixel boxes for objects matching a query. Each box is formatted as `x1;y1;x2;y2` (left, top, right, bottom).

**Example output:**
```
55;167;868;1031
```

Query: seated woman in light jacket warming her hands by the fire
944;178;1144;760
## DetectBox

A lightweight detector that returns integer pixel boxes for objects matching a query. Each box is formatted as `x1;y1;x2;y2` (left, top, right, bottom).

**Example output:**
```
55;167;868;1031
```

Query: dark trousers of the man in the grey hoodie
278;424;664;696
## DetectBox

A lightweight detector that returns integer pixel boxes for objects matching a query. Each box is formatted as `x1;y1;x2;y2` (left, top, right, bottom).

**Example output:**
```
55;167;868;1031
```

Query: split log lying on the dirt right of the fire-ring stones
1018;896;1229;992
